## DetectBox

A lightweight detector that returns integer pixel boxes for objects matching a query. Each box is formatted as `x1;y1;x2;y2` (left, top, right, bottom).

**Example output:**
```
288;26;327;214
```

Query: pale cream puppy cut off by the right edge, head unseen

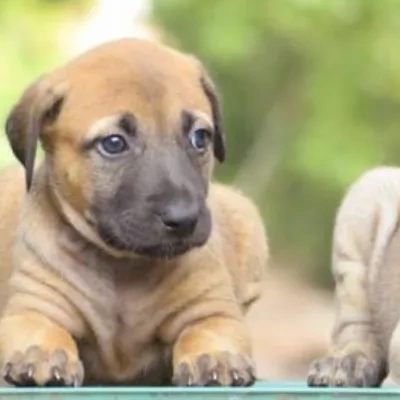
308;167;400;386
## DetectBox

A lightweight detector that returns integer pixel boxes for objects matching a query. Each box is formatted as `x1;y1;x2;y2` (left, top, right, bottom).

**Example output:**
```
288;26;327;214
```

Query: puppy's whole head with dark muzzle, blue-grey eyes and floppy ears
6;39;225;257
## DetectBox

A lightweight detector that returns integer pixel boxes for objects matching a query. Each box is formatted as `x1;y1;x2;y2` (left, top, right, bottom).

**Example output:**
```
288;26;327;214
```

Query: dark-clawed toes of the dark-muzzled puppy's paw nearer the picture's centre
172;352;256;386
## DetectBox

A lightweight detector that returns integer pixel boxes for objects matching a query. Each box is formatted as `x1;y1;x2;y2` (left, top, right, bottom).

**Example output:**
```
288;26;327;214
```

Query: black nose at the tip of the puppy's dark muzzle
160;204;199;237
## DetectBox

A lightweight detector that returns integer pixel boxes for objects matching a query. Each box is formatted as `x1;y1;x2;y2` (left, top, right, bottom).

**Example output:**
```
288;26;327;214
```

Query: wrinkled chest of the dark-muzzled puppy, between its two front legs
56;234;178;384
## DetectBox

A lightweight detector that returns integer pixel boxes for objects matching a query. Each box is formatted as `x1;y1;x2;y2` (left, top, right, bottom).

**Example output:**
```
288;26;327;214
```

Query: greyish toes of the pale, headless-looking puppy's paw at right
307;351;385;387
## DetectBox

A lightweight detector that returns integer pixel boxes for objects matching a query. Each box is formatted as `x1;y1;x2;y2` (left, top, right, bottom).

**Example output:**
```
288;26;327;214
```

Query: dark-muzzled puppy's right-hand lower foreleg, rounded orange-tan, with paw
173;316;255;386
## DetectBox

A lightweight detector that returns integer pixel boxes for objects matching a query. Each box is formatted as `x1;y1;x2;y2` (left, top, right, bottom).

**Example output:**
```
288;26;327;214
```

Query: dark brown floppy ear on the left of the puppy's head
6;77;65;191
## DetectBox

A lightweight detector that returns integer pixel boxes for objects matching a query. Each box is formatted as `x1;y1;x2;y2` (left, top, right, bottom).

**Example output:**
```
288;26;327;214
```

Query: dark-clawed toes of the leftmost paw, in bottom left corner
3;346;84;386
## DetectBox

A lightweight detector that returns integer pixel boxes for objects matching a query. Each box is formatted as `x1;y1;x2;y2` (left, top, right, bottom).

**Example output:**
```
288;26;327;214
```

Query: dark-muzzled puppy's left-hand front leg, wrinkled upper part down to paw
0;244;85;386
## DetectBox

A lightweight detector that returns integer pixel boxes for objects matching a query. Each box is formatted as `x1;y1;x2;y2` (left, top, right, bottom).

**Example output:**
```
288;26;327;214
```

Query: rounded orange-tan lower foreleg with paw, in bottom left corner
0;311;83;386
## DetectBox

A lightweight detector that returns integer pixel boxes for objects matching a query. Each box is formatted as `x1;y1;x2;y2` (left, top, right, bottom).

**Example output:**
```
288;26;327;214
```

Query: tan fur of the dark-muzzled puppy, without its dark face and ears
0;41;268;384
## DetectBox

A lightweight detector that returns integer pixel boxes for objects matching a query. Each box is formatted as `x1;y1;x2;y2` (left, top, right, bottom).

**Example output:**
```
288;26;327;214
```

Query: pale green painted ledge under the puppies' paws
0;382;400;400
